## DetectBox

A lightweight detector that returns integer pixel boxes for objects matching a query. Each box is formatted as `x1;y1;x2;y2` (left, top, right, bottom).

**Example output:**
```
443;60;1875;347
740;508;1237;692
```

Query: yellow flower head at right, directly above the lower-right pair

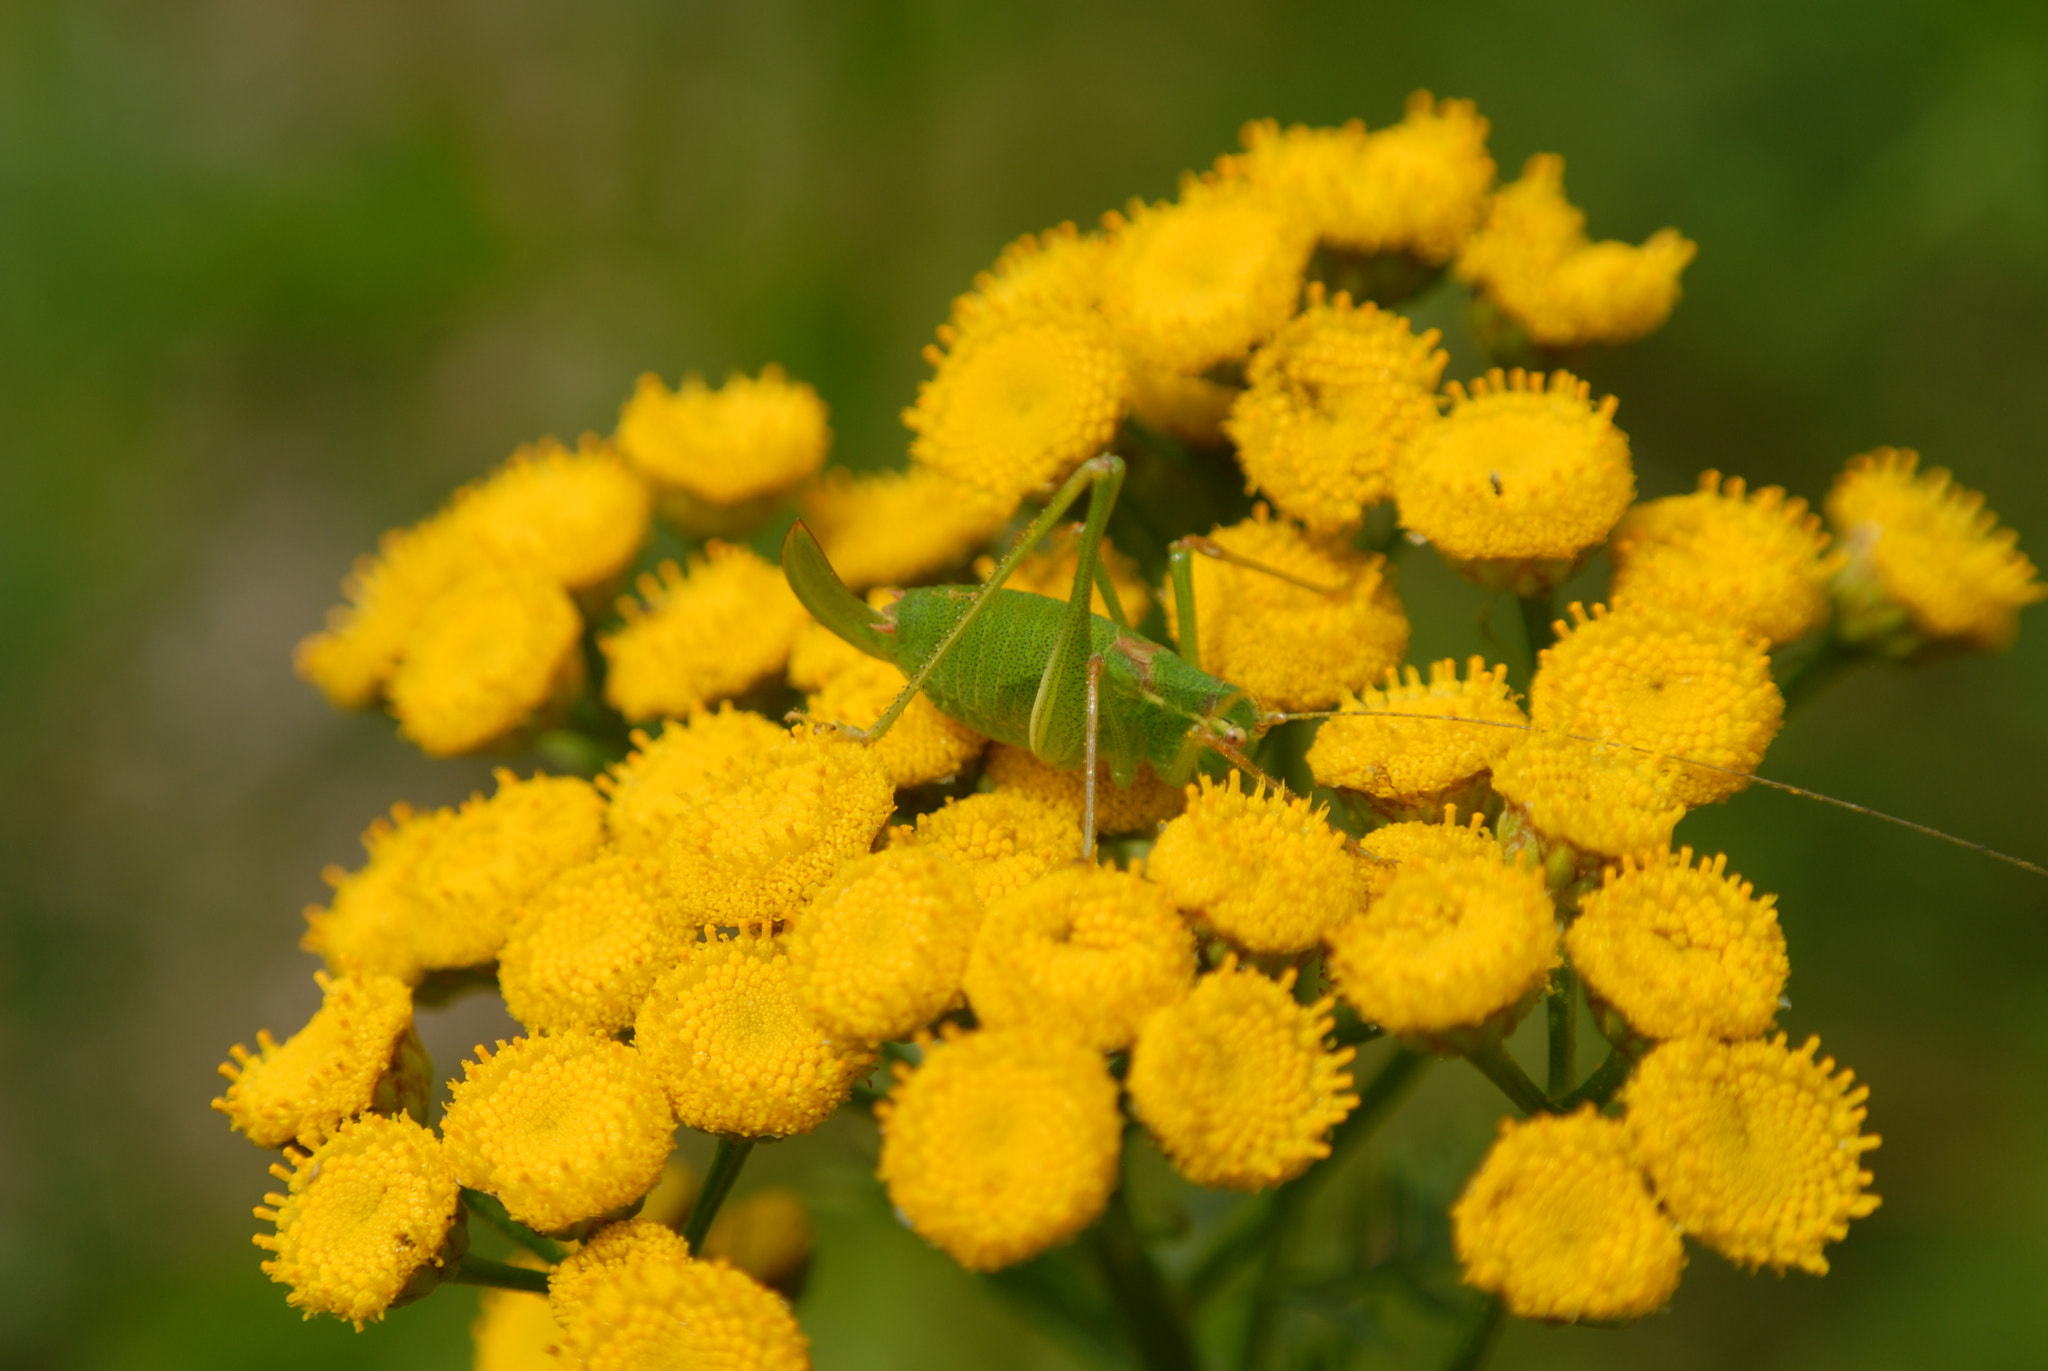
1565;848;1792;1039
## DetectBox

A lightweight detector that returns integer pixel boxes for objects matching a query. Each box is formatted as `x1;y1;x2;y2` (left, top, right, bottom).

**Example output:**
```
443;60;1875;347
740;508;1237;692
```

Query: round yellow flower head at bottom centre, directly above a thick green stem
874;1031;1122;1271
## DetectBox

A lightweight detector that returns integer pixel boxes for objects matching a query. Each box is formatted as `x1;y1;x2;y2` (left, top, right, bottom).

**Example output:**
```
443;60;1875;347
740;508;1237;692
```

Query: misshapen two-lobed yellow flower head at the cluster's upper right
1458;152;1700;348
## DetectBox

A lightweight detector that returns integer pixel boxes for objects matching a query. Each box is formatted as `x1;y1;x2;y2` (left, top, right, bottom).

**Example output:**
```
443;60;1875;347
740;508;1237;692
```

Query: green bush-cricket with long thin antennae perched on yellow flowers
782;453;2048;877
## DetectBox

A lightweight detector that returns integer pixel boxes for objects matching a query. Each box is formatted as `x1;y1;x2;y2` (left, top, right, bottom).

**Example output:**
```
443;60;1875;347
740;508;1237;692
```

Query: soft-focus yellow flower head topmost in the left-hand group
618;365;831;533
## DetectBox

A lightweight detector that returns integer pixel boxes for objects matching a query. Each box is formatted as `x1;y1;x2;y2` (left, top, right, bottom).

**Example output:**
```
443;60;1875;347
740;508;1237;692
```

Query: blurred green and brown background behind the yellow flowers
0;0;2048;1371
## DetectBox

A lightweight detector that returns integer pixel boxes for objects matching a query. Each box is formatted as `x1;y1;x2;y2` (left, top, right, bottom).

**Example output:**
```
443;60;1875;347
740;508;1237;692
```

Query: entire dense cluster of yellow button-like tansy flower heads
215;94;2044;1369
